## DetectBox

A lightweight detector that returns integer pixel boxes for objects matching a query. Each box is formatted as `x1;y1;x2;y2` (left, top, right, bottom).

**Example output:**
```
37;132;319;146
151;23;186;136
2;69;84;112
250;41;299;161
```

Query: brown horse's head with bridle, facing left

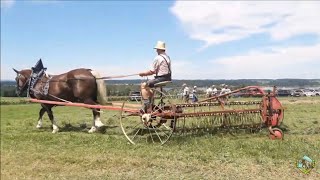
13;68;32;96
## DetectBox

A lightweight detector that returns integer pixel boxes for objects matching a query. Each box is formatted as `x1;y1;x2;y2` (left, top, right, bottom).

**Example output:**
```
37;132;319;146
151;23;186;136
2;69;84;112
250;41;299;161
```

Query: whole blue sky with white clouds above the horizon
1;0;320;80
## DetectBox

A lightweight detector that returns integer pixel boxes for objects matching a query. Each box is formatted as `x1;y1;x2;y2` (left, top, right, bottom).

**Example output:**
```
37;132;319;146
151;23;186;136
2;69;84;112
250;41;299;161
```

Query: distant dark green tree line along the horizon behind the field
1;79;320;97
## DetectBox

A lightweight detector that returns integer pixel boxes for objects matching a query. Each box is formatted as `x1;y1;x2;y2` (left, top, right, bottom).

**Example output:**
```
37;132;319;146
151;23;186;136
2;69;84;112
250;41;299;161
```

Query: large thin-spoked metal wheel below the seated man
120;91;176;145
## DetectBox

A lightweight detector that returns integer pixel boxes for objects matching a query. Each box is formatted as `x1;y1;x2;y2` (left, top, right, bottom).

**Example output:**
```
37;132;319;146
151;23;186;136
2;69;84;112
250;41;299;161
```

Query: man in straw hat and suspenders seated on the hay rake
139;41;171;113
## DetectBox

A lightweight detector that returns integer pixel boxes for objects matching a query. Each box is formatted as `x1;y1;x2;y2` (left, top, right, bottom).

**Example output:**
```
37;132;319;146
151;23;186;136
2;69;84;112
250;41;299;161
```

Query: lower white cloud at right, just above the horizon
211;43;320;79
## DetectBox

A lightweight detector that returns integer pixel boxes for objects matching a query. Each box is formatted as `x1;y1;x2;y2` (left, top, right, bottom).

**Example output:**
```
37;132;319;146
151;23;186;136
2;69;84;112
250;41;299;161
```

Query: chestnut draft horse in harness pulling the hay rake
13;68;106;133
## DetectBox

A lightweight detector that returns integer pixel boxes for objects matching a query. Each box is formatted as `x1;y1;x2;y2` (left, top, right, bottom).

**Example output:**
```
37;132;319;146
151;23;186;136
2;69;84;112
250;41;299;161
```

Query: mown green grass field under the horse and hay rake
1;97;320;180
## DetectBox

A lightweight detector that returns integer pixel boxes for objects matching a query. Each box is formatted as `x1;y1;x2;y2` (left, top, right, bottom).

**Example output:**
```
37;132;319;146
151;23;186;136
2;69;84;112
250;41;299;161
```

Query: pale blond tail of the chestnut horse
91;70;107;105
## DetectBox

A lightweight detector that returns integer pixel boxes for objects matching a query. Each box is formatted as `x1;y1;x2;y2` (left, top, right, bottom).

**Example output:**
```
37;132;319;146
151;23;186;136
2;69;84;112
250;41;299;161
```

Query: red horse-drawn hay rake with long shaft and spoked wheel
30;85;284;144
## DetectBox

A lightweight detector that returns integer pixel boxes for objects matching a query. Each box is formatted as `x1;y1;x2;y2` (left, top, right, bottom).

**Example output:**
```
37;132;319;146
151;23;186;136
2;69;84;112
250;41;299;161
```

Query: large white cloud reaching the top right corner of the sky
170;1;320;47
